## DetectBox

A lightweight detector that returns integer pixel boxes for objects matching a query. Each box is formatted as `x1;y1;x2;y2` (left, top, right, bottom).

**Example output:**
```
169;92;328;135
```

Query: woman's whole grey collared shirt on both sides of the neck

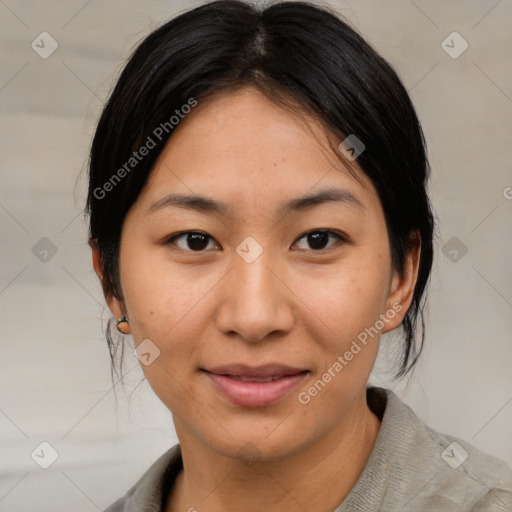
104;387;512;512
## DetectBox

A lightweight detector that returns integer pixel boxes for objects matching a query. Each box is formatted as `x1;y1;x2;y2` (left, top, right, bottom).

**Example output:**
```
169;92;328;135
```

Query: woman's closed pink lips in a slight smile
205;364;308;407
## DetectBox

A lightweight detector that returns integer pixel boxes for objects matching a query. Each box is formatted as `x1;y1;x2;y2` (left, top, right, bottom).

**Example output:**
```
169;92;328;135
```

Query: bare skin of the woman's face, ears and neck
93;86;419;512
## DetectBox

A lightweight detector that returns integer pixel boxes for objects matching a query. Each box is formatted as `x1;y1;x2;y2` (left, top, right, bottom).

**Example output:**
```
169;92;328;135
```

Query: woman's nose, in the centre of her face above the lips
216;245;294;343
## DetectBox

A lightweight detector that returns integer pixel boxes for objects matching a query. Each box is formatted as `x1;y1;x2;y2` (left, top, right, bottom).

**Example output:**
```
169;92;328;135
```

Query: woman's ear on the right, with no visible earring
382;231;421;333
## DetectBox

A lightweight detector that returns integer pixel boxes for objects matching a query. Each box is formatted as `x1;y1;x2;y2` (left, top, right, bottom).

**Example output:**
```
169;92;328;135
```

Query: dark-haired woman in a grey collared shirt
88;0;512;512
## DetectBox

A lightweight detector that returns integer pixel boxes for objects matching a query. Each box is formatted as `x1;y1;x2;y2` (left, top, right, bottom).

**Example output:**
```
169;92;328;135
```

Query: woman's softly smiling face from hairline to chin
94;87;414;458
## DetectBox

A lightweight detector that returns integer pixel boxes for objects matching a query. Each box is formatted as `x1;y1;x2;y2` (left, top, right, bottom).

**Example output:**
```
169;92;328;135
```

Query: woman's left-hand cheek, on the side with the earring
121;253;212;408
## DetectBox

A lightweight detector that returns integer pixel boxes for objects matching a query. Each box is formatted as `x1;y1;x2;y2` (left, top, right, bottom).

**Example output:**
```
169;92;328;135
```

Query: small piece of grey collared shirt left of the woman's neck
104;444;182;512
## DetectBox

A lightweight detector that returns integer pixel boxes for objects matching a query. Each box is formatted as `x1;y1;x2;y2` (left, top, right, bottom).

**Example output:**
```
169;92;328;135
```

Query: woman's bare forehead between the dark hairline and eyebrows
138;87;376;216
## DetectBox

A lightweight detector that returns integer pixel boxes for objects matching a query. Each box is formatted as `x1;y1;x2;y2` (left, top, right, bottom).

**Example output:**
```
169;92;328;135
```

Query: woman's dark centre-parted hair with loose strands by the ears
86;0;434;377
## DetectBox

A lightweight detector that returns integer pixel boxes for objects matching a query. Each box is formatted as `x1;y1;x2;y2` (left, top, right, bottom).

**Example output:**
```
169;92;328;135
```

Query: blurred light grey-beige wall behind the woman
0;0;512;512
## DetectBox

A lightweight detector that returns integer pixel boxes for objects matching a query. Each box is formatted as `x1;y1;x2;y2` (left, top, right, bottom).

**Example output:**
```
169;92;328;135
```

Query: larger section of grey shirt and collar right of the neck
356;388;512;512
